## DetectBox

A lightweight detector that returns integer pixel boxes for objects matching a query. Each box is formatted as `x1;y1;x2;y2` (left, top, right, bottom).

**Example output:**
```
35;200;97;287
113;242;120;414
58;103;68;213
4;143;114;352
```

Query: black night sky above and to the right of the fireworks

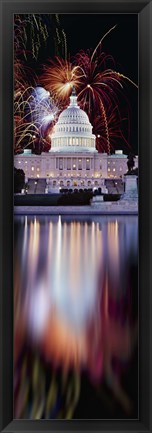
16;14;138;154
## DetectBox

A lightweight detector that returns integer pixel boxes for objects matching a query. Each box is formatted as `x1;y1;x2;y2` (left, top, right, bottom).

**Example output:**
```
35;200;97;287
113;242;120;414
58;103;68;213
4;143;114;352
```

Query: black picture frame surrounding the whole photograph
0;0;152;433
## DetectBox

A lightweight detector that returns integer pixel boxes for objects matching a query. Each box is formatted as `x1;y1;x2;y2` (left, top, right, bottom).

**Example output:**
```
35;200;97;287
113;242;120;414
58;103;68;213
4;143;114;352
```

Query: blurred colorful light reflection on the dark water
14;216;138;419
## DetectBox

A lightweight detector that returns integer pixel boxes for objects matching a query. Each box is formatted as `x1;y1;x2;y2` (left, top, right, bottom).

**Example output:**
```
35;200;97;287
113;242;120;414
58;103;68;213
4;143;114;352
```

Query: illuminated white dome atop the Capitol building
51;88;96;152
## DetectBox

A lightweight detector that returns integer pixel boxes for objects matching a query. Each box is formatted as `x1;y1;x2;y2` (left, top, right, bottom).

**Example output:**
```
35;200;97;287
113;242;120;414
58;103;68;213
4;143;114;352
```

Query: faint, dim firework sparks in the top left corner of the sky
14;14;67;61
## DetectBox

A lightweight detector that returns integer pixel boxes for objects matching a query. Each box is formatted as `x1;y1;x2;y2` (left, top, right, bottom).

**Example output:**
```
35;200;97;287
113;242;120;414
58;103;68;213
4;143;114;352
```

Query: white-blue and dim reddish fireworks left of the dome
14;14;66;153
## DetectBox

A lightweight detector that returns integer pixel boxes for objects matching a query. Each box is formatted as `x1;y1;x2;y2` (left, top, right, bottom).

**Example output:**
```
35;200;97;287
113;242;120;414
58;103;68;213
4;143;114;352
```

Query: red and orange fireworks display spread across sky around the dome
14;15;138;153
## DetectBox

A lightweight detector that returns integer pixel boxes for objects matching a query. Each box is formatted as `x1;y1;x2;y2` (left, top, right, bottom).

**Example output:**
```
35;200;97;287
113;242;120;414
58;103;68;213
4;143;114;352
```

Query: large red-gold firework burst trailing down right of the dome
75;27;136;153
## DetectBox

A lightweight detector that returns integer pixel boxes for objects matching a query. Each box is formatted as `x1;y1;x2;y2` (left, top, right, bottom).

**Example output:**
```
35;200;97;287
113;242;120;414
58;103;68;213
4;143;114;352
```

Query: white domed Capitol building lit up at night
14;89;138;193
